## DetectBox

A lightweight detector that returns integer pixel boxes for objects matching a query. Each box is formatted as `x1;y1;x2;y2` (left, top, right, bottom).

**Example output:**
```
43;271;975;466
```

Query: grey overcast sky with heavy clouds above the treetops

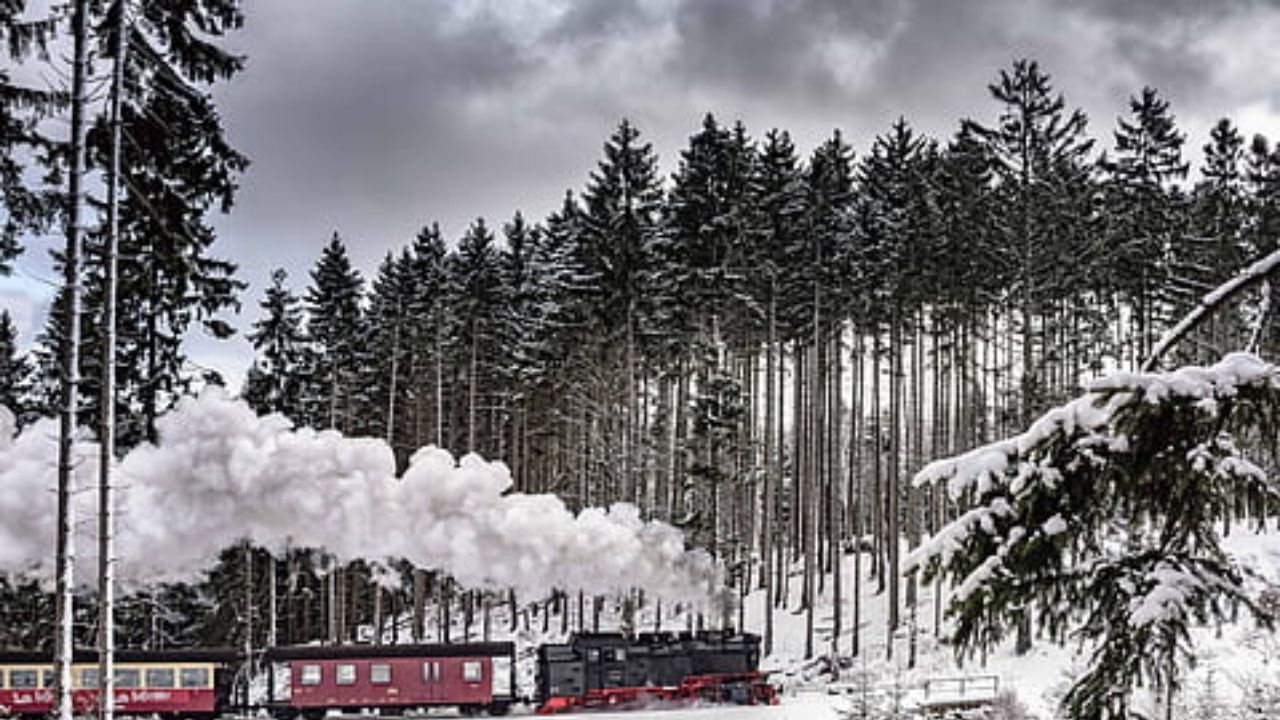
0;0;1280;383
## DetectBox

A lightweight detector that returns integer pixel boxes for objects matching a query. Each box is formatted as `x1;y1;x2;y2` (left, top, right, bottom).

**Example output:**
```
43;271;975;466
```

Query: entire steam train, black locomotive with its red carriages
0;632;776;720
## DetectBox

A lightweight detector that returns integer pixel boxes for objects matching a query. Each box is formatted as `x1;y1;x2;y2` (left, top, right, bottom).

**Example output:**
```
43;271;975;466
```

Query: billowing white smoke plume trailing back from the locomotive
0;391;719;600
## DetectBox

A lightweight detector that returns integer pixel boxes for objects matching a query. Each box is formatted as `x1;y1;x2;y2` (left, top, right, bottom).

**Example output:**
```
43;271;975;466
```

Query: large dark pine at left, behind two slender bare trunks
31;0;248;448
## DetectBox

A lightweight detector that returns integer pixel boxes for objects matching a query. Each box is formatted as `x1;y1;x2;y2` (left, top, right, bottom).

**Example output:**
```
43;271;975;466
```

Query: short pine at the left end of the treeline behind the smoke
244;269;307;424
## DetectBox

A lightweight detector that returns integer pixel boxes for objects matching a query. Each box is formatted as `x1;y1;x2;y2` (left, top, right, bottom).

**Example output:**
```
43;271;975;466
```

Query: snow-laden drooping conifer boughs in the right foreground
909;354;1280;720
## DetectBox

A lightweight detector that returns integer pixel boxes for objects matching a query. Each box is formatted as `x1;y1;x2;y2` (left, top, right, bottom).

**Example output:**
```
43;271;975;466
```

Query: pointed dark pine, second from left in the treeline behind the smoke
306;232;365;432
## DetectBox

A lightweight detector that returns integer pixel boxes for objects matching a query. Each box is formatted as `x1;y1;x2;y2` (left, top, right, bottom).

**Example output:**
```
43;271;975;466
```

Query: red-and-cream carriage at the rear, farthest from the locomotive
0;650;239;717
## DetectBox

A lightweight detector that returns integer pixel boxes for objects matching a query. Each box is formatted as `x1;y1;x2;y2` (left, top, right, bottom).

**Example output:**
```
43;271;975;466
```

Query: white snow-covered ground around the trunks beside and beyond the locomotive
442;523;1280;720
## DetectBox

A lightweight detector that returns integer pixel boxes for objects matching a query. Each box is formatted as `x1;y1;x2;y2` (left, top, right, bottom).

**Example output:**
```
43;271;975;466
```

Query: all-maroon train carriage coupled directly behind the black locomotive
264;642;516;720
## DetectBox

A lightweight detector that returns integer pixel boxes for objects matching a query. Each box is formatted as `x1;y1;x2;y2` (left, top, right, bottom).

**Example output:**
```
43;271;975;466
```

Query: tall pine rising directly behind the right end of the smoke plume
655;114;760;556
